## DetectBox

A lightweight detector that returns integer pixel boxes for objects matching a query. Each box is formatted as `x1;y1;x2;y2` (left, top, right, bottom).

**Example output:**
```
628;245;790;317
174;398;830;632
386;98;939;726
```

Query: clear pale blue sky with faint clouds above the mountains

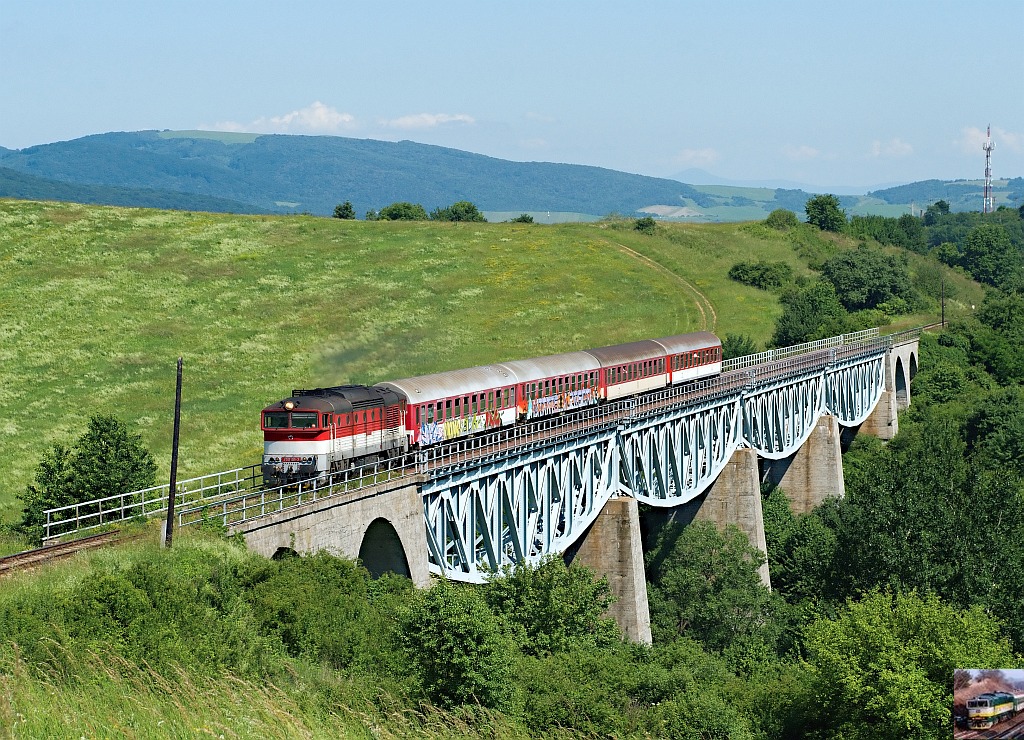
0;0;1024;187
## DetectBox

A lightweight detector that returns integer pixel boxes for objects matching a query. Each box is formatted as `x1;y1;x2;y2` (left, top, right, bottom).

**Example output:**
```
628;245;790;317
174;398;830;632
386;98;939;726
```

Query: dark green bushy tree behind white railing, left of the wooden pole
20;415;157;538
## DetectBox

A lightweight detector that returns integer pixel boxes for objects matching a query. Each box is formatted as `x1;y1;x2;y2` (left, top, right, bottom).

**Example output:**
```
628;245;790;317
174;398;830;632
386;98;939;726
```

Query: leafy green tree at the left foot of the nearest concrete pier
484;555;622;655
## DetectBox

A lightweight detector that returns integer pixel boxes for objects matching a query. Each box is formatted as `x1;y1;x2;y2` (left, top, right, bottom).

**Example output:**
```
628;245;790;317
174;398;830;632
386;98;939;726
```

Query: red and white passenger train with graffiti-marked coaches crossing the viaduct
262;332;722;485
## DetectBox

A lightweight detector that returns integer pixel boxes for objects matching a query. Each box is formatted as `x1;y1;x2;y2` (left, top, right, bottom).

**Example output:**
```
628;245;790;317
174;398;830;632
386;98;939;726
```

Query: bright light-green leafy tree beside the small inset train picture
806;592;1014;740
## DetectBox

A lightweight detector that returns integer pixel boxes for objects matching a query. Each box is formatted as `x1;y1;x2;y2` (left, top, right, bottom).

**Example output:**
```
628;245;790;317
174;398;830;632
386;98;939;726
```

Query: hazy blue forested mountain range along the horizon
0;131;1024;221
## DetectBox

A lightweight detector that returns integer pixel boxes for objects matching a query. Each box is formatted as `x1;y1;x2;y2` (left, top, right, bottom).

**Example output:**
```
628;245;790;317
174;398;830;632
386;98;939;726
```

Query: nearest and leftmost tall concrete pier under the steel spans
564;497;651;645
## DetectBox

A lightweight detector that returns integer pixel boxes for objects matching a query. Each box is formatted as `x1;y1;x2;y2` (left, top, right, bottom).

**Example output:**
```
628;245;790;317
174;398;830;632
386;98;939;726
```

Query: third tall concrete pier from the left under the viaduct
764;415;846;514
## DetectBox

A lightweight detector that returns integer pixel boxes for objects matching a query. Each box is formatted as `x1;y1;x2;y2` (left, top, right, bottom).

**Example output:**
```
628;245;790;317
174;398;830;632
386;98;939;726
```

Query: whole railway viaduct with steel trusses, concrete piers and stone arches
225;331;920;642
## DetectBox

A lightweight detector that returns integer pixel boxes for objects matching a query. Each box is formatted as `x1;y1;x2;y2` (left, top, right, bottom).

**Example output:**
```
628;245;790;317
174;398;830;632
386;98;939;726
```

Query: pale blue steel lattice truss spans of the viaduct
421;348;885;582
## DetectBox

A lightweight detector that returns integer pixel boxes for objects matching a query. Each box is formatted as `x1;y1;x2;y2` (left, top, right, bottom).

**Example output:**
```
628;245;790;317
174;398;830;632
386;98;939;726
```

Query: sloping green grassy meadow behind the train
0;201;962;521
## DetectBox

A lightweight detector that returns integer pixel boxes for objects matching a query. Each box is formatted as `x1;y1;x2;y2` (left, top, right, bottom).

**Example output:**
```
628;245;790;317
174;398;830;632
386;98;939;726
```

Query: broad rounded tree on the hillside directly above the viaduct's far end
821;245;915;311
